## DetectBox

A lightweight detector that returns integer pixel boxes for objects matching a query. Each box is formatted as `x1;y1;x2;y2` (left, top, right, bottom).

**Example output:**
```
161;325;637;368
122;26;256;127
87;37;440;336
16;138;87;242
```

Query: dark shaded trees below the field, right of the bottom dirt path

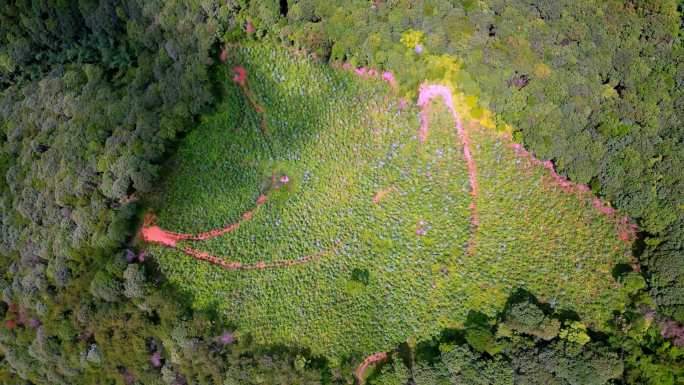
370;296;684;385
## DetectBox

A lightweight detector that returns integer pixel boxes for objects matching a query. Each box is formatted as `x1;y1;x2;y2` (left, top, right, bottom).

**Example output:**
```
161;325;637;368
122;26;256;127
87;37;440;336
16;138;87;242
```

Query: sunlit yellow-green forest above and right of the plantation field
272;0;684;322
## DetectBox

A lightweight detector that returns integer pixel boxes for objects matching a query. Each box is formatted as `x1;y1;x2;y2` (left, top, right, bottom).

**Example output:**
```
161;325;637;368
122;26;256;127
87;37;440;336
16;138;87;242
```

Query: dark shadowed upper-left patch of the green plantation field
138;45;390;232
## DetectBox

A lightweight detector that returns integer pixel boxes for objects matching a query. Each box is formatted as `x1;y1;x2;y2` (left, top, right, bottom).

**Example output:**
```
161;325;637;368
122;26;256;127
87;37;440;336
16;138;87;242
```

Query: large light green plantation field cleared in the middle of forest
147;45;630;357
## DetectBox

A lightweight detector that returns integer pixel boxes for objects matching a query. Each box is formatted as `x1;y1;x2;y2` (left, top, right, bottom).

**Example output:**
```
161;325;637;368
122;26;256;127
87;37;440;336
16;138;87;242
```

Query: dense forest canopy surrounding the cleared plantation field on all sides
0;0;684;385
